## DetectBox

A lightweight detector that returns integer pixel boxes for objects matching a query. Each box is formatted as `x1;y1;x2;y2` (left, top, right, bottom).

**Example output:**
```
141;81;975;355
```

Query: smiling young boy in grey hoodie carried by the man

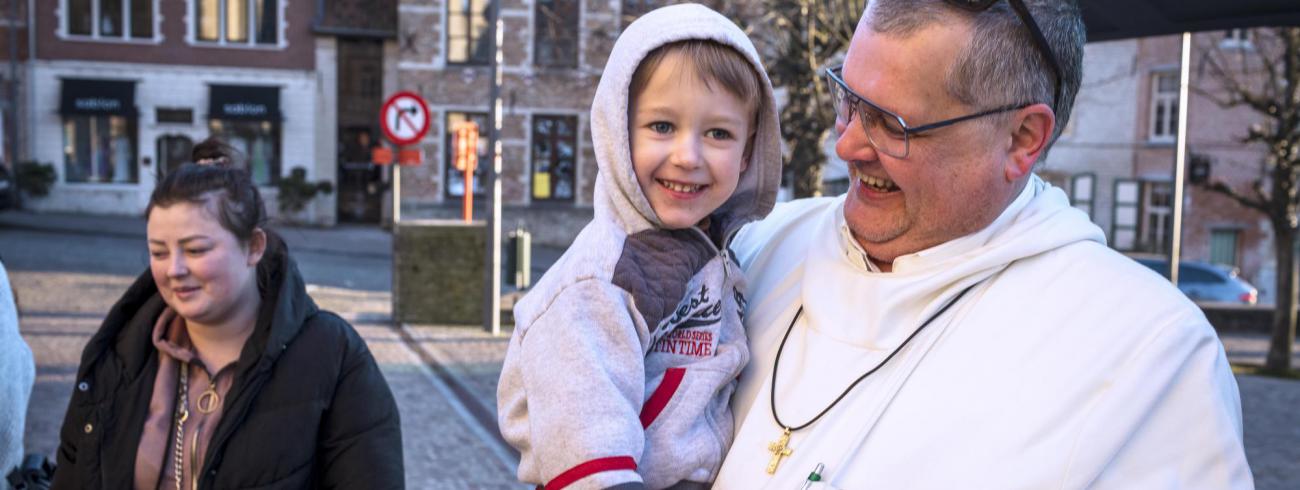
497;4;781;489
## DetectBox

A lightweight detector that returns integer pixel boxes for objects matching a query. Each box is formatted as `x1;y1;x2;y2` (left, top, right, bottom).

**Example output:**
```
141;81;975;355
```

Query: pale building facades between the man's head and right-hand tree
1040;30;1275;303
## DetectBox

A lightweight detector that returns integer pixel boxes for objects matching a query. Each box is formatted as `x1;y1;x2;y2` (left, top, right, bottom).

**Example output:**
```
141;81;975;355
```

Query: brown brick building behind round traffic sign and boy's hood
398;0;753;246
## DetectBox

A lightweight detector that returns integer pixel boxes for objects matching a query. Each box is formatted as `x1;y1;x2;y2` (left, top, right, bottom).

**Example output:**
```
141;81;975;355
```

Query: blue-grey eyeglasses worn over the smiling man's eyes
826;66;1030;159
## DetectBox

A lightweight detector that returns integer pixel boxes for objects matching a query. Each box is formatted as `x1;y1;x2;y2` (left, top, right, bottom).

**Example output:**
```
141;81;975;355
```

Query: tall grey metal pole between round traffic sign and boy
484;0;504;335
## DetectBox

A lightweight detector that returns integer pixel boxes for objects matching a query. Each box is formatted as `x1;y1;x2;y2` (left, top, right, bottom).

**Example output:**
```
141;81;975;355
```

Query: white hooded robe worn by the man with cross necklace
716;177;1253;489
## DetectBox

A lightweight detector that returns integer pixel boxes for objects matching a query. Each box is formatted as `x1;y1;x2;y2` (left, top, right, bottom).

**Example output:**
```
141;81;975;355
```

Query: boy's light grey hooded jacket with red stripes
497;4;781;489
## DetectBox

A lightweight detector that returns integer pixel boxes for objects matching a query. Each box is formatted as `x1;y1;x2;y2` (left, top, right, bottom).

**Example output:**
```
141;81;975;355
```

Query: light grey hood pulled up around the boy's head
592;4;781;237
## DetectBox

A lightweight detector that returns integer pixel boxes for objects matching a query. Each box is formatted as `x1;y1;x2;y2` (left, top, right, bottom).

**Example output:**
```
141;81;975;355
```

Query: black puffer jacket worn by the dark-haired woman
53;237;404;490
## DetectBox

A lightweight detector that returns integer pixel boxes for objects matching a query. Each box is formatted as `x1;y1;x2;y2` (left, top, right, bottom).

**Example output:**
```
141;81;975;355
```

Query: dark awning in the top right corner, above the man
1079;0;1300;43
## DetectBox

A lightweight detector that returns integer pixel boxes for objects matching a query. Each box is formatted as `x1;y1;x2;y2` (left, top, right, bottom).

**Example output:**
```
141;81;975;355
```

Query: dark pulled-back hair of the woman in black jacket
144;164;267;244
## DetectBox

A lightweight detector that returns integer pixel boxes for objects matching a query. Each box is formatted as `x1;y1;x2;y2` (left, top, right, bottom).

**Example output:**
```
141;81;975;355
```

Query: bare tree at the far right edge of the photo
1197;27;1300;373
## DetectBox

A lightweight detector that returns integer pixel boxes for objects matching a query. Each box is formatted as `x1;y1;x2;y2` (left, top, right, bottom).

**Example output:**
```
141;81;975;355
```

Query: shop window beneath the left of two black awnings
64;114;139;183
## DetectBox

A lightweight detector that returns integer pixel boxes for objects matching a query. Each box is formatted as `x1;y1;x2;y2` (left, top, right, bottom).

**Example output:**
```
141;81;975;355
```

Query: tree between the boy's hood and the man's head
753;0;867;198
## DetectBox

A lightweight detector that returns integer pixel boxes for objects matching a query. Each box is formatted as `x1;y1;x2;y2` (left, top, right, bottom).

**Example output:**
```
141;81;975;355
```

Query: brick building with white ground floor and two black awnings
1;0;397;225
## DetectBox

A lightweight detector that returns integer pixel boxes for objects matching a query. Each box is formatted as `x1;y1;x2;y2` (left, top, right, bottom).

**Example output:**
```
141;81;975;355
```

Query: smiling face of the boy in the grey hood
628;52;754;229
